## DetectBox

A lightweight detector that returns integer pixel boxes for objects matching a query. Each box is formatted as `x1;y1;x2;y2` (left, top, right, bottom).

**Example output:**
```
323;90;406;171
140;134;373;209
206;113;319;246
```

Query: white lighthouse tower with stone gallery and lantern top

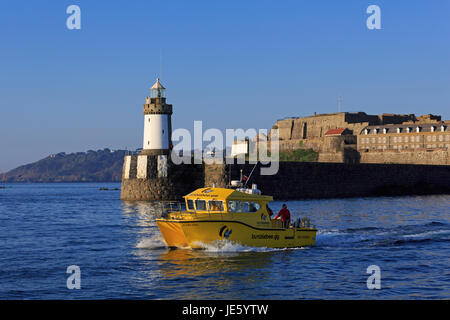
141;78;172;156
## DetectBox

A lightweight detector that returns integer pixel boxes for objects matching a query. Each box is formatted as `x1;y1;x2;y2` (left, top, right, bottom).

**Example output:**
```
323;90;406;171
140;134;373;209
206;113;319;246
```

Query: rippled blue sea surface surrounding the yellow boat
0;183;450;299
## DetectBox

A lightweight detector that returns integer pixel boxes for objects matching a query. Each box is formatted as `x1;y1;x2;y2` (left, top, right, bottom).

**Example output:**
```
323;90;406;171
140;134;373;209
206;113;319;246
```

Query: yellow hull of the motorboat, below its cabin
156;219;317;249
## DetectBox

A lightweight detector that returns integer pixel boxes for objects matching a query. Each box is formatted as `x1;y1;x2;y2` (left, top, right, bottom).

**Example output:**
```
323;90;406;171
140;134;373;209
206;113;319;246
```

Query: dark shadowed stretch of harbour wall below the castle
227;162;450;200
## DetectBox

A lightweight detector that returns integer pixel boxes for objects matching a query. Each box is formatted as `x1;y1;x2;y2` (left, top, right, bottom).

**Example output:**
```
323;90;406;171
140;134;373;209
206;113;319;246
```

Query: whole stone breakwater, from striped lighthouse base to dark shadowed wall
121;155;450;201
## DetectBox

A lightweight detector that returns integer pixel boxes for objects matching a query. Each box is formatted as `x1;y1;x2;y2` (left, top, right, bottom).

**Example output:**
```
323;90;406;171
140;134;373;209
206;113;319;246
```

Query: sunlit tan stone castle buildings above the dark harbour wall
273;112;450;165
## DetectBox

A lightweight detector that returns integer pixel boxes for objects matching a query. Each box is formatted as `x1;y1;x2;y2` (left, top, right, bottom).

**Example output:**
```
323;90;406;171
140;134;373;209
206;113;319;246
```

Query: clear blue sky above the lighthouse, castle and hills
0;0;450;170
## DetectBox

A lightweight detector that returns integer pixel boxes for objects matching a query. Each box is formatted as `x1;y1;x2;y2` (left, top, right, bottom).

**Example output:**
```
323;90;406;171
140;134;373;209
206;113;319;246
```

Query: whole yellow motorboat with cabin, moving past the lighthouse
156;187;317;249
